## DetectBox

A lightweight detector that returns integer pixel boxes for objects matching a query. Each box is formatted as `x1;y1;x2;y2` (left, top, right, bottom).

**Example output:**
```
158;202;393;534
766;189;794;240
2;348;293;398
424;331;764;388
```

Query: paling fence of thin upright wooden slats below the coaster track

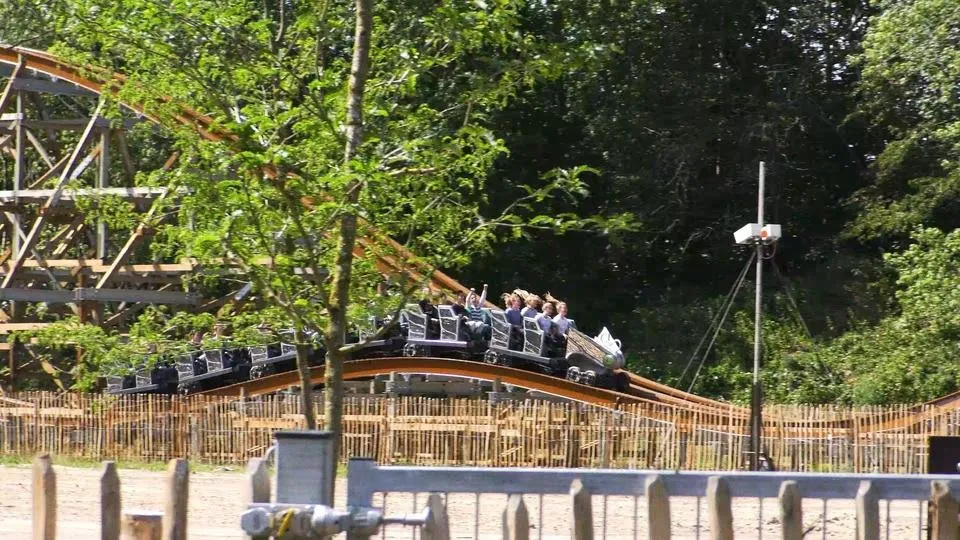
0;393;960;473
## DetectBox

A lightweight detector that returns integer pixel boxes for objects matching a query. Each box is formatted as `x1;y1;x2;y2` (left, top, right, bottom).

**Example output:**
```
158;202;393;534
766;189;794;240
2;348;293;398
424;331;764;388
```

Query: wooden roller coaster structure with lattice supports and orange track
0;46;960;428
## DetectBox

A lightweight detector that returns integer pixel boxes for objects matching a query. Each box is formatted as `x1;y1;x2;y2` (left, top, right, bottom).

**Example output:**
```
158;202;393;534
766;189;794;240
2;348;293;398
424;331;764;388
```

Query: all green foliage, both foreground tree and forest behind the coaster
0;0;960;403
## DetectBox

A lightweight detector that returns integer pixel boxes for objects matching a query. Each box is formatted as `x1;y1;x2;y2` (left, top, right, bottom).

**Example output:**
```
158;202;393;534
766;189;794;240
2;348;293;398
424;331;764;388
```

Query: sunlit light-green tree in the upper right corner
849;0;960;240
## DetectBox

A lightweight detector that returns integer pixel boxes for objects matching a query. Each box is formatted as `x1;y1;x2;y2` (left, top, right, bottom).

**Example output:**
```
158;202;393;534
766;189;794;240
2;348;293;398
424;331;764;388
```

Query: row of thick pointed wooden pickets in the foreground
26;454;960;540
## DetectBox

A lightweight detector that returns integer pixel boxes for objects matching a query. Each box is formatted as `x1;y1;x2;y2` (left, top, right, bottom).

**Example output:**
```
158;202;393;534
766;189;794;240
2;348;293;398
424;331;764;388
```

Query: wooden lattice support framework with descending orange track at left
0;46;478;380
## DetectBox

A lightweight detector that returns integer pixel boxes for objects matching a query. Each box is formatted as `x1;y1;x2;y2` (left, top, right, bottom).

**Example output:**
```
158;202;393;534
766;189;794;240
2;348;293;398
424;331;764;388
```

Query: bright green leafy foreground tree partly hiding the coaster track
33;0;628;480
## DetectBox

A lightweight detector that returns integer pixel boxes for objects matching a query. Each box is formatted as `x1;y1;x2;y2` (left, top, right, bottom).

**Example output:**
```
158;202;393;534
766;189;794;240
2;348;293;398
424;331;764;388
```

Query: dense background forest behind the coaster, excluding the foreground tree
0;0;960;403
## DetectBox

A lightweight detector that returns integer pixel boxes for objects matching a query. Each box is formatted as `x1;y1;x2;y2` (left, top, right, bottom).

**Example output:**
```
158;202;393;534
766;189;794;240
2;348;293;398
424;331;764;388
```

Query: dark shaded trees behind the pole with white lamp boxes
466;0;877;376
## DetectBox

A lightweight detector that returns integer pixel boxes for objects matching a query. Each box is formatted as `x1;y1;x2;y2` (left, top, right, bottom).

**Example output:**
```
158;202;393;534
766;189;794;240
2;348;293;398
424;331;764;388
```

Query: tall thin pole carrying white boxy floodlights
733;161;782;471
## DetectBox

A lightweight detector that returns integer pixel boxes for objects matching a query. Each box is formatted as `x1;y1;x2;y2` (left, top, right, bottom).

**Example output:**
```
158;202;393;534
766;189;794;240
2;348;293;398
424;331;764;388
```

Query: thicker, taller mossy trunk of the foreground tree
323;0;373;503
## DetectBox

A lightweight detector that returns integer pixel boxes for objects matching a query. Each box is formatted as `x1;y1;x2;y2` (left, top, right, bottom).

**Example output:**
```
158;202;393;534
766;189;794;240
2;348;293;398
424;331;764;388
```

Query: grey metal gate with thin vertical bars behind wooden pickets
346;459;960;539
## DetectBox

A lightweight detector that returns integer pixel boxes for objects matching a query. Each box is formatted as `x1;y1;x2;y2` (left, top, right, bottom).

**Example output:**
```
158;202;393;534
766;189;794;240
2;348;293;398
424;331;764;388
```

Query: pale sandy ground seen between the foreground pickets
0;466;919;540
